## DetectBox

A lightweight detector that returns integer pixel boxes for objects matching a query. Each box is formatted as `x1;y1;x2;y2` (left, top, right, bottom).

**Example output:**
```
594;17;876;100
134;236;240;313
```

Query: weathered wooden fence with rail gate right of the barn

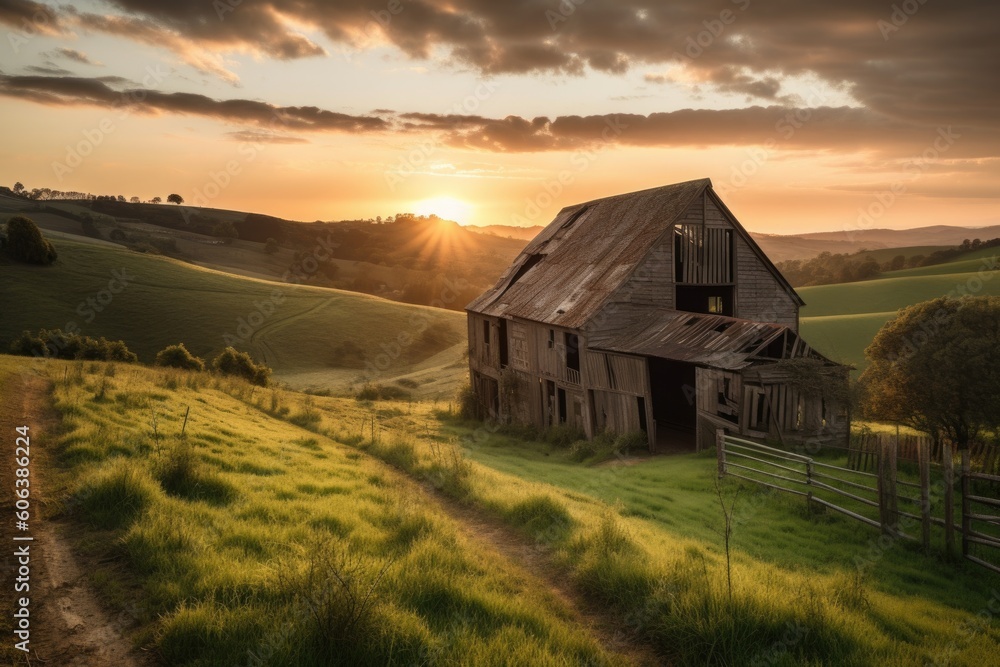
716;429;1000;572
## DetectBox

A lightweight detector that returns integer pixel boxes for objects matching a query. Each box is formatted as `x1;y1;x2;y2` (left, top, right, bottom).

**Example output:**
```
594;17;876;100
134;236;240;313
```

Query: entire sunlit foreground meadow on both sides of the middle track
9;357;1000;666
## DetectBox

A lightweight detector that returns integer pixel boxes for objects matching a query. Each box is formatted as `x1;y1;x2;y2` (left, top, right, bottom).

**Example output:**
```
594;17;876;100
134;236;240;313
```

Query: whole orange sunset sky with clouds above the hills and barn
0;0;1000;233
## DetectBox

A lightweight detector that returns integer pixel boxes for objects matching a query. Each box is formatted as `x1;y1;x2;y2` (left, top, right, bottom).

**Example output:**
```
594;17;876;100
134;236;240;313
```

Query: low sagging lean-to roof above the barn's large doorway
587;307;832;370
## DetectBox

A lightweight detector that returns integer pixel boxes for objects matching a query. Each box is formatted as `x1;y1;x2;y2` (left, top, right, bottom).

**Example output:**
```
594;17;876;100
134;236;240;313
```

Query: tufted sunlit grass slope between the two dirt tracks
0;357;617;665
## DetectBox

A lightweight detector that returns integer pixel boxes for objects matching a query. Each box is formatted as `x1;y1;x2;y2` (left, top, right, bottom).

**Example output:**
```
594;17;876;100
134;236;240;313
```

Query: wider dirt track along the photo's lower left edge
0;374;157;667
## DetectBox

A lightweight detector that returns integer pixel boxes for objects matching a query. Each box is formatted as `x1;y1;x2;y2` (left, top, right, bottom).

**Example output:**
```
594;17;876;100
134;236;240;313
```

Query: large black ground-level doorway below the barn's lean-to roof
649;357;698;450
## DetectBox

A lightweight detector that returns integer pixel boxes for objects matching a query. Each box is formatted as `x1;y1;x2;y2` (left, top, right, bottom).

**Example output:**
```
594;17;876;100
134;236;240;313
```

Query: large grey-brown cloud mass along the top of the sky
27;0;988;126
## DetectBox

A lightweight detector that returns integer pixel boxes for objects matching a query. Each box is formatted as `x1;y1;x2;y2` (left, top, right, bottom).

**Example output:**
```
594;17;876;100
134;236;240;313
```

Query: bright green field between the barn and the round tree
797;248;1000;371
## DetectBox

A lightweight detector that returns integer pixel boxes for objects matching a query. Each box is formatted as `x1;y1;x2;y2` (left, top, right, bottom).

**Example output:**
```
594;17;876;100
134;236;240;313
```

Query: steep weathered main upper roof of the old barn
466;178;798;329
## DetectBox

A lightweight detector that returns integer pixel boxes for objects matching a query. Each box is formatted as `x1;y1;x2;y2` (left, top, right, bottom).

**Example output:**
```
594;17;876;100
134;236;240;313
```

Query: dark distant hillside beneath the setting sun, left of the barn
0;196;524;310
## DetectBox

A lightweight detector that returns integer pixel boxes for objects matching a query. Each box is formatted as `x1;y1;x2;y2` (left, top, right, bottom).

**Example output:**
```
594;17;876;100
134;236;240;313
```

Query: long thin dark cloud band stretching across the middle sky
0;74;1000;160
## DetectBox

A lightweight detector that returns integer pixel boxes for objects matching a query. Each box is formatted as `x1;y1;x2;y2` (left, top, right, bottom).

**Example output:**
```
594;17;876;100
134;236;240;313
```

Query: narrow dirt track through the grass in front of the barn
429;490;667;667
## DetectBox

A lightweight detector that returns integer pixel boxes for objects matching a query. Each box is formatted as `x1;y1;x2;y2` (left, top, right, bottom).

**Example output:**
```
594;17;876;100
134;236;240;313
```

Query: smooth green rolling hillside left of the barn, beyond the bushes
0;237;466;397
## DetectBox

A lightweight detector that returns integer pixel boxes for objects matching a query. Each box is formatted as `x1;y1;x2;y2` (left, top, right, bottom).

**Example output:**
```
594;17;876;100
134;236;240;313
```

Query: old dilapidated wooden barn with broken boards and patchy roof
466;179;849;451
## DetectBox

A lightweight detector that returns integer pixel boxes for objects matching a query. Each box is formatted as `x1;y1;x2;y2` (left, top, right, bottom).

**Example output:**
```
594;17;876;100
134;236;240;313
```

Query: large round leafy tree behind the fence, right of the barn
860;296;1000;449
